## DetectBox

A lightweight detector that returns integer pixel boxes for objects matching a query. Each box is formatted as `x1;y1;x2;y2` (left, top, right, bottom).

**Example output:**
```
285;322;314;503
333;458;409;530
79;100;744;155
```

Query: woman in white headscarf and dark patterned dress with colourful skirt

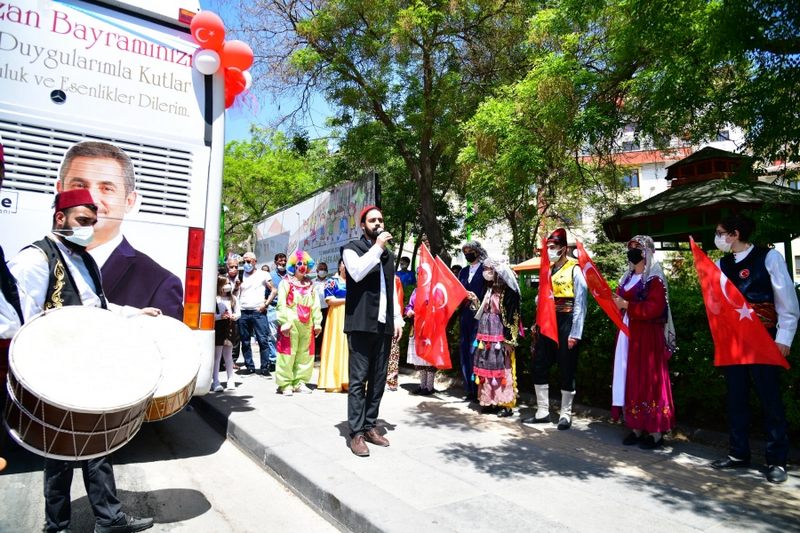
473;259;520;417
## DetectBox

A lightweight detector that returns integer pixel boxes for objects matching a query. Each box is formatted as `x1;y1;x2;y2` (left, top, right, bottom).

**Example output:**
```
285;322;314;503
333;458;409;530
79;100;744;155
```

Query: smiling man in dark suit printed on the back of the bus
56;141;183;320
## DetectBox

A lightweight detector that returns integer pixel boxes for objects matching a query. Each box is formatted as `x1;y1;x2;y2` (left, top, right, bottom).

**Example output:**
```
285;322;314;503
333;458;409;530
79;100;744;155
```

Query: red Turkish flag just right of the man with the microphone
414;244;467;369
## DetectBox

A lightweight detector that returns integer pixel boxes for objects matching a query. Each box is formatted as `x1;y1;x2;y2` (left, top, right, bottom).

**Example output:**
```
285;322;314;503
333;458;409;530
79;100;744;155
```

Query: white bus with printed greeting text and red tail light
0;0;224;394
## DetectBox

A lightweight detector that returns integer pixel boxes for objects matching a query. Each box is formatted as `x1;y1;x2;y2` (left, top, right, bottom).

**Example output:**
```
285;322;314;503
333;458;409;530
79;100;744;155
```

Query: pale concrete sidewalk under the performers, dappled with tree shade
193;366;800;533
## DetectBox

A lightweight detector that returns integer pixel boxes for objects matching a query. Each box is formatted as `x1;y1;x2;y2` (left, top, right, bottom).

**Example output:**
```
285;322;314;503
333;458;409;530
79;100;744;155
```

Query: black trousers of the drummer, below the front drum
44;455;125;532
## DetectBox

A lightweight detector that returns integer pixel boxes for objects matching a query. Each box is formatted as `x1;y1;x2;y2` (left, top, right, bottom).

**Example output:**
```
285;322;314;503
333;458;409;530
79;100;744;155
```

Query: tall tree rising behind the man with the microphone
242;0;536;253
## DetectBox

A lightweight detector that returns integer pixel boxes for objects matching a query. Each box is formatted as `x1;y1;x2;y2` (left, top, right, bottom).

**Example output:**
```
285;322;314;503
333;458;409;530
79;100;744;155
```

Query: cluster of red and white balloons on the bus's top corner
189;11;253;108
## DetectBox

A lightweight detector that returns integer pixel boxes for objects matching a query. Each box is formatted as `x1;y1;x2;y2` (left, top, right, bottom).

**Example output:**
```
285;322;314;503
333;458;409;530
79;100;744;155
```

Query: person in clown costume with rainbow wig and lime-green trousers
275;250;322;396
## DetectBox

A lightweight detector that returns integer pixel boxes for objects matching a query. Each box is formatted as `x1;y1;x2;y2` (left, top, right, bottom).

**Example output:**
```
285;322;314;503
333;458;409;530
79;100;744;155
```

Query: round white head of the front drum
9;305;161;413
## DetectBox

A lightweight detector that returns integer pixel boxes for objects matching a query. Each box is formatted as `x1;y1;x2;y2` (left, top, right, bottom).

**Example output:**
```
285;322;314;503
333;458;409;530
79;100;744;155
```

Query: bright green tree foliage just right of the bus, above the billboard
222;127;332;254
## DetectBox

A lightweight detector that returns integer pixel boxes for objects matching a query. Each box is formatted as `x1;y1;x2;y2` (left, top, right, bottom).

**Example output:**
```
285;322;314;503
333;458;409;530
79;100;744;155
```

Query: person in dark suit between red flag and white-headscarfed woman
458;241;486;401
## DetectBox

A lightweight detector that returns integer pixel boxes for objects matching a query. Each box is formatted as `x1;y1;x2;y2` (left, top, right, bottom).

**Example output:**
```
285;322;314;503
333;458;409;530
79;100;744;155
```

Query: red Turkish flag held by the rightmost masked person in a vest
690;238;789;369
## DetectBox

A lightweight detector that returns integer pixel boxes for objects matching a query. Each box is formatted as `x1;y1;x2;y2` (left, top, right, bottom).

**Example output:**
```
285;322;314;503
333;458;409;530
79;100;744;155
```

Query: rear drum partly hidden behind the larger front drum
130;315;200;422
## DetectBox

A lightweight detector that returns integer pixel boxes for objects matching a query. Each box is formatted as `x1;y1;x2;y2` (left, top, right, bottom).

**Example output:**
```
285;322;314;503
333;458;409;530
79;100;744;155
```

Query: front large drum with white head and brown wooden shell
5;306;161;460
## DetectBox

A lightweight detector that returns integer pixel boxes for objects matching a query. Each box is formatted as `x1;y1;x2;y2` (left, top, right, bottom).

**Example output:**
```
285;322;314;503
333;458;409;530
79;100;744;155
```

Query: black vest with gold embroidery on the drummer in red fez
32;237;108;310
